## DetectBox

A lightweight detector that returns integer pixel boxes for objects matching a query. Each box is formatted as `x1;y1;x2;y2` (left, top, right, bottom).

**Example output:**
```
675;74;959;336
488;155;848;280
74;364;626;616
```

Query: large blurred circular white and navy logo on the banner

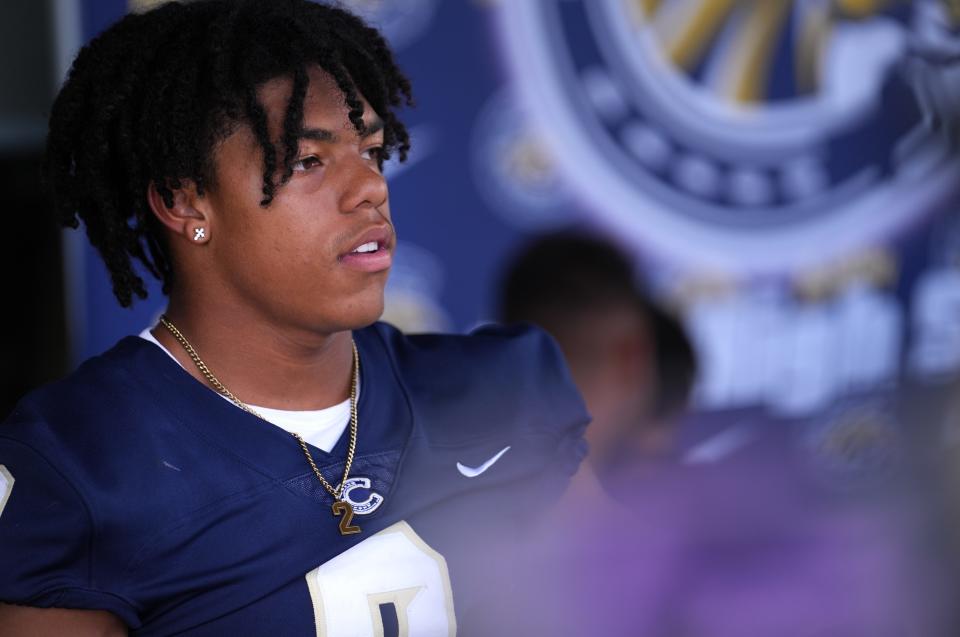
499;0;960;273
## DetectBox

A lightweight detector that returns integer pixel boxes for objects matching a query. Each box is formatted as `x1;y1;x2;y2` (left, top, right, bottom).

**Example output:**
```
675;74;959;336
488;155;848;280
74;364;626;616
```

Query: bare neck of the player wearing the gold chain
153;296;353;410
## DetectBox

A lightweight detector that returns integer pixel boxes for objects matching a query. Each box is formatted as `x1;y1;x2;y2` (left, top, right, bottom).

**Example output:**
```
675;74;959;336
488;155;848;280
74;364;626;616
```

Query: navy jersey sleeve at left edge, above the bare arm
0;412;139;626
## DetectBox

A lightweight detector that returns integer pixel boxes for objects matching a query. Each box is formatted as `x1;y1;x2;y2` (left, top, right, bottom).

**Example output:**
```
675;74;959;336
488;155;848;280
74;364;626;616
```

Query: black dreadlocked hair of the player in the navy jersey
44;0;413;307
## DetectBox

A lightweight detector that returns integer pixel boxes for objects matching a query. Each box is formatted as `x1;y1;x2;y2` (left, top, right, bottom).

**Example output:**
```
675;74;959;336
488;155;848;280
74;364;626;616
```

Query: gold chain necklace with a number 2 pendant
160;314;360;535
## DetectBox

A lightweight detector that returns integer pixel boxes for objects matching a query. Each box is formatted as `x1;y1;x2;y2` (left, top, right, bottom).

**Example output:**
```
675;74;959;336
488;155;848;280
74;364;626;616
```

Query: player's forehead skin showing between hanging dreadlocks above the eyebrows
257;66;374;134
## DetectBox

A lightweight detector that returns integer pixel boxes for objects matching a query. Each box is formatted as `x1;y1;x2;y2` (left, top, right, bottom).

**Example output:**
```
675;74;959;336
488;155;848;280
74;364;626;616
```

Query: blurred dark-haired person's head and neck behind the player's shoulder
499;232;697;484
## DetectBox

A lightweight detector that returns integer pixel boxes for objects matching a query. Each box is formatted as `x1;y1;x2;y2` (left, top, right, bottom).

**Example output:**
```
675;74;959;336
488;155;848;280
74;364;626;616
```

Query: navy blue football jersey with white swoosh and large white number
0;323;588;636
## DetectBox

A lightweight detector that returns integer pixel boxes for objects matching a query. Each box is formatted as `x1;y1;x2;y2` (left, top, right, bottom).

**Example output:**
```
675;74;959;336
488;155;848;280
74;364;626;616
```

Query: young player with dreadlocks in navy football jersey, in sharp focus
0;0;587;636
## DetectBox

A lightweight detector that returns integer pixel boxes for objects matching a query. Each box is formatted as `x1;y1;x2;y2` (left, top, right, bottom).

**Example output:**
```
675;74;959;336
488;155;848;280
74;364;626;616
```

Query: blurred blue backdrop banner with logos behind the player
75;0;960;462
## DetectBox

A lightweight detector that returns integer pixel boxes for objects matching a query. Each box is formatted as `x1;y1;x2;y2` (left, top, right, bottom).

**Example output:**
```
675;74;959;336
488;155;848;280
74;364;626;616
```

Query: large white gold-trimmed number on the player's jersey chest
307;522;457;637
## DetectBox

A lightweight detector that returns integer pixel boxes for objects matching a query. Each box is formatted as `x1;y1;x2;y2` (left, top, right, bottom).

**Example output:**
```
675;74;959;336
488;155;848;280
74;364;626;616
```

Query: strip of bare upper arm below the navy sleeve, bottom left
0;604;127;637
